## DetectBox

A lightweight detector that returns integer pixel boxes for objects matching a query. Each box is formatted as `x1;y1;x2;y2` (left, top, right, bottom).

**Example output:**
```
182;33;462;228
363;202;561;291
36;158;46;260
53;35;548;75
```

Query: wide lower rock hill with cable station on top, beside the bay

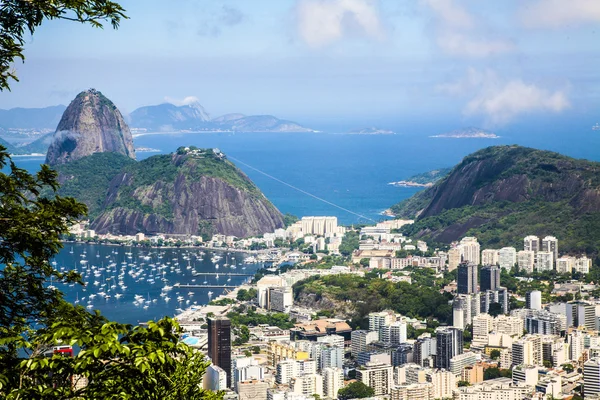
92;149;284;237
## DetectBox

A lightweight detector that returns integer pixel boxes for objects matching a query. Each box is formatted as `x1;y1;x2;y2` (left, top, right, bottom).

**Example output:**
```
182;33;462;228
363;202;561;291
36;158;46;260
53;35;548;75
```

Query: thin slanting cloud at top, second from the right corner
421;0;514;57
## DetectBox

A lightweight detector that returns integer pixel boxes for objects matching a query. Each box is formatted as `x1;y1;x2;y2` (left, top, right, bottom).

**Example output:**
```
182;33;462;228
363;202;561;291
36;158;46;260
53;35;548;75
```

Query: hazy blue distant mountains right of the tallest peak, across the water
128;103;314;132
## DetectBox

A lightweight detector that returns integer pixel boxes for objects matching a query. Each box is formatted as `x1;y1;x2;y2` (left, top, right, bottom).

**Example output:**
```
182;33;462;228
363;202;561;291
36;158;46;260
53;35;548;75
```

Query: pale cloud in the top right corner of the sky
519;0;600;28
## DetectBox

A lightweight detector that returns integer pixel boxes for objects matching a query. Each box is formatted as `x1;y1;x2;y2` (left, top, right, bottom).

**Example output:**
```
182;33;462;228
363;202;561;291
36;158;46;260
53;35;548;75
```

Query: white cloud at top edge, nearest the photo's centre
296;0;384;47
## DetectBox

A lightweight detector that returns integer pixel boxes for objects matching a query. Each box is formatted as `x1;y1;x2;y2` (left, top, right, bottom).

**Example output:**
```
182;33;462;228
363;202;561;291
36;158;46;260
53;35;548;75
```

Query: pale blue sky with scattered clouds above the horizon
0;0;600;128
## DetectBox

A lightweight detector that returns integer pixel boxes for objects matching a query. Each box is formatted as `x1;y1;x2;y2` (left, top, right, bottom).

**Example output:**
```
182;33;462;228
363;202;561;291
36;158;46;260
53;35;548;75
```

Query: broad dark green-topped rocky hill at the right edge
391;146;600;252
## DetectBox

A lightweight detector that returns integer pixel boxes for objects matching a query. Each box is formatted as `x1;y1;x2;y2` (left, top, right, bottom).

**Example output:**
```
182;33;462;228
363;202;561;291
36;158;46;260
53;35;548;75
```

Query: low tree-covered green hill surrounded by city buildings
294;272;452;325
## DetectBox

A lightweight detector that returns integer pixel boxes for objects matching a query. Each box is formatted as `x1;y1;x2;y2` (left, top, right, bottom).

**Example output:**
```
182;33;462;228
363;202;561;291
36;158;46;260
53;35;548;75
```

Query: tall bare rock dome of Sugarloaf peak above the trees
46;89;135;165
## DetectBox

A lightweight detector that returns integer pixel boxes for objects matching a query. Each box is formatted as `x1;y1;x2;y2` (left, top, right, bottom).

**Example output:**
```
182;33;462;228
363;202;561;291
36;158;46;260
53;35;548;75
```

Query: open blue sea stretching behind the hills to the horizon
15;120;600;225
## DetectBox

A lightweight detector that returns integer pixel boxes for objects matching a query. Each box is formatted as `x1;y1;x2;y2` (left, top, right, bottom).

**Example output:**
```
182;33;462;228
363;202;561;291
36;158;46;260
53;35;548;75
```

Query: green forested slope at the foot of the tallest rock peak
52;153;135;218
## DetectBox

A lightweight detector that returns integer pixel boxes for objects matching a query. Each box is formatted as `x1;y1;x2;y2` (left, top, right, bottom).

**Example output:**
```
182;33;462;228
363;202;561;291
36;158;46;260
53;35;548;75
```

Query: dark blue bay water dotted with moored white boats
49;243;260;324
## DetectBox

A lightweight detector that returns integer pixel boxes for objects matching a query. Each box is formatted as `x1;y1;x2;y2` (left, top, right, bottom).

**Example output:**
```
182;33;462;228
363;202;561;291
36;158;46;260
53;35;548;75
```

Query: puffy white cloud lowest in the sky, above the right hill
438;68;570;125
